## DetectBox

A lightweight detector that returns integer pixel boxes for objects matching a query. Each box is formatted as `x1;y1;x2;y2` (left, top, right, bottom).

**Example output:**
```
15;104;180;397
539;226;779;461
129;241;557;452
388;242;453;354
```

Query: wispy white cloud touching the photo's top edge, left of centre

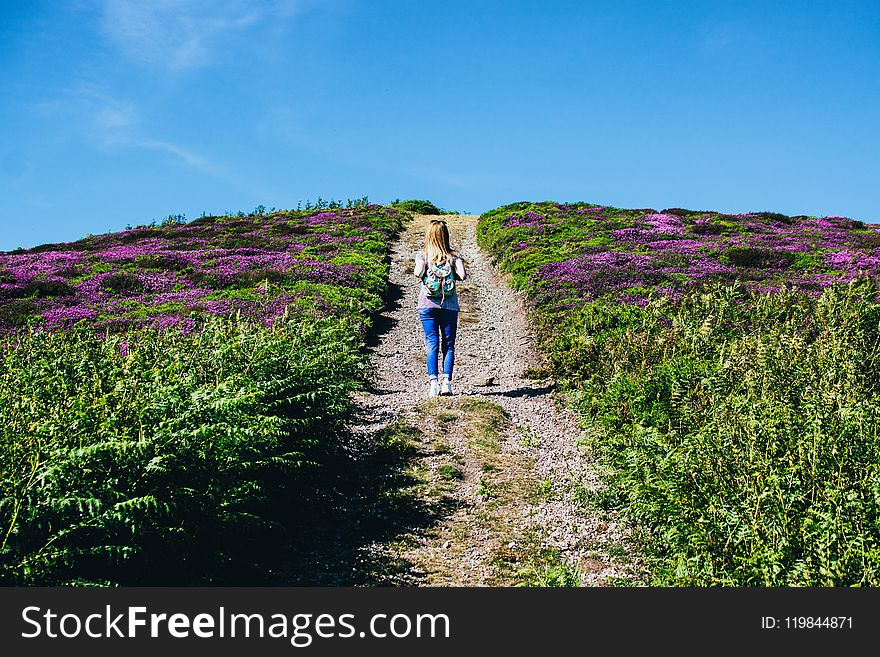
101;0;303;71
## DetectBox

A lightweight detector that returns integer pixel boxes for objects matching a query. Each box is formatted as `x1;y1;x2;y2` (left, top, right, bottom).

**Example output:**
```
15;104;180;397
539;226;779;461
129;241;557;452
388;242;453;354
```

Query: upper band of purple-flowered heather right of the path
480;203;880;307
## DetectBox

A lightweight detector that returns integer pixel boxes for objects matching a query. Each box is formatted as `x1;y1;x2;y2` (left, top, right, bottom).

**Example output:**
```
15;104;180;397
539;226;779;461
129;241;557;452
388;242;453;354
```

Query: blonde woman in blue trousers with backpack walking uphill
415;219;467;397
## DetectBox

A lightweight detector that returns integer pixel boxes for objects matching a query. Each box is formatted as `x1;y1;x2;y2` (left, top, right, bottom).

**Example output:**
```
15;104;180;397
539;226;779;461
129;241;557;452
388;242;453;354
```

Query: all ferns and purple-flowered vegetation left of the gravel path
0;205;406;584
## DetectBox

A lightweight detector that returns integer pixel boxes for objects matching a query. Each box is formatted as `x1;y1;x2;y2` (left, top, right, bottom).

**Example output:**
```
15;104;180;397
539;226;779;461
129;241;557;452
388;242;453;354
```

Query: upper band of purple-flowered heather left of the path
0;205;403;334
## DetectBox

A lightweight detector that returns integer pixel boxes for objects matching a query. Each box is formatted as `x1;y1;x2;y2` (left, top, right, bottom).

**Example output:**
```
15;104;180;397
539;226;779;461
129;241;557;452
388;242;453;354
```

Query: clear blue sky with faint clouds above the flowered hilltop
0;0;880;250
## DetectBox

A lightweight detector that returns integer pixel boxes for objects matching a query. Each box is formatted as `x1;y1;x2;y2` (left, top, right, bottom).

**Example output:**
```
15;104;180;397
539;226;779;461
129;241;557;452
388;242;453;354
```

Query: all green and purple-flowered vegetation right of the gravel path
478;203;880;586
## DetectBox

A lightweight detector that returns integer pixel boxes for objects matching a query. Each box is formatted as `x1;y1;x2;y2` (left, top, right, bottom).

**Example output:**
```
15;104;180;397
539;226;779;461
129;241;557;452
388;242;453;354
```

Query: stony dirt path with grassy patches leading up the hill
338;215;634;585
